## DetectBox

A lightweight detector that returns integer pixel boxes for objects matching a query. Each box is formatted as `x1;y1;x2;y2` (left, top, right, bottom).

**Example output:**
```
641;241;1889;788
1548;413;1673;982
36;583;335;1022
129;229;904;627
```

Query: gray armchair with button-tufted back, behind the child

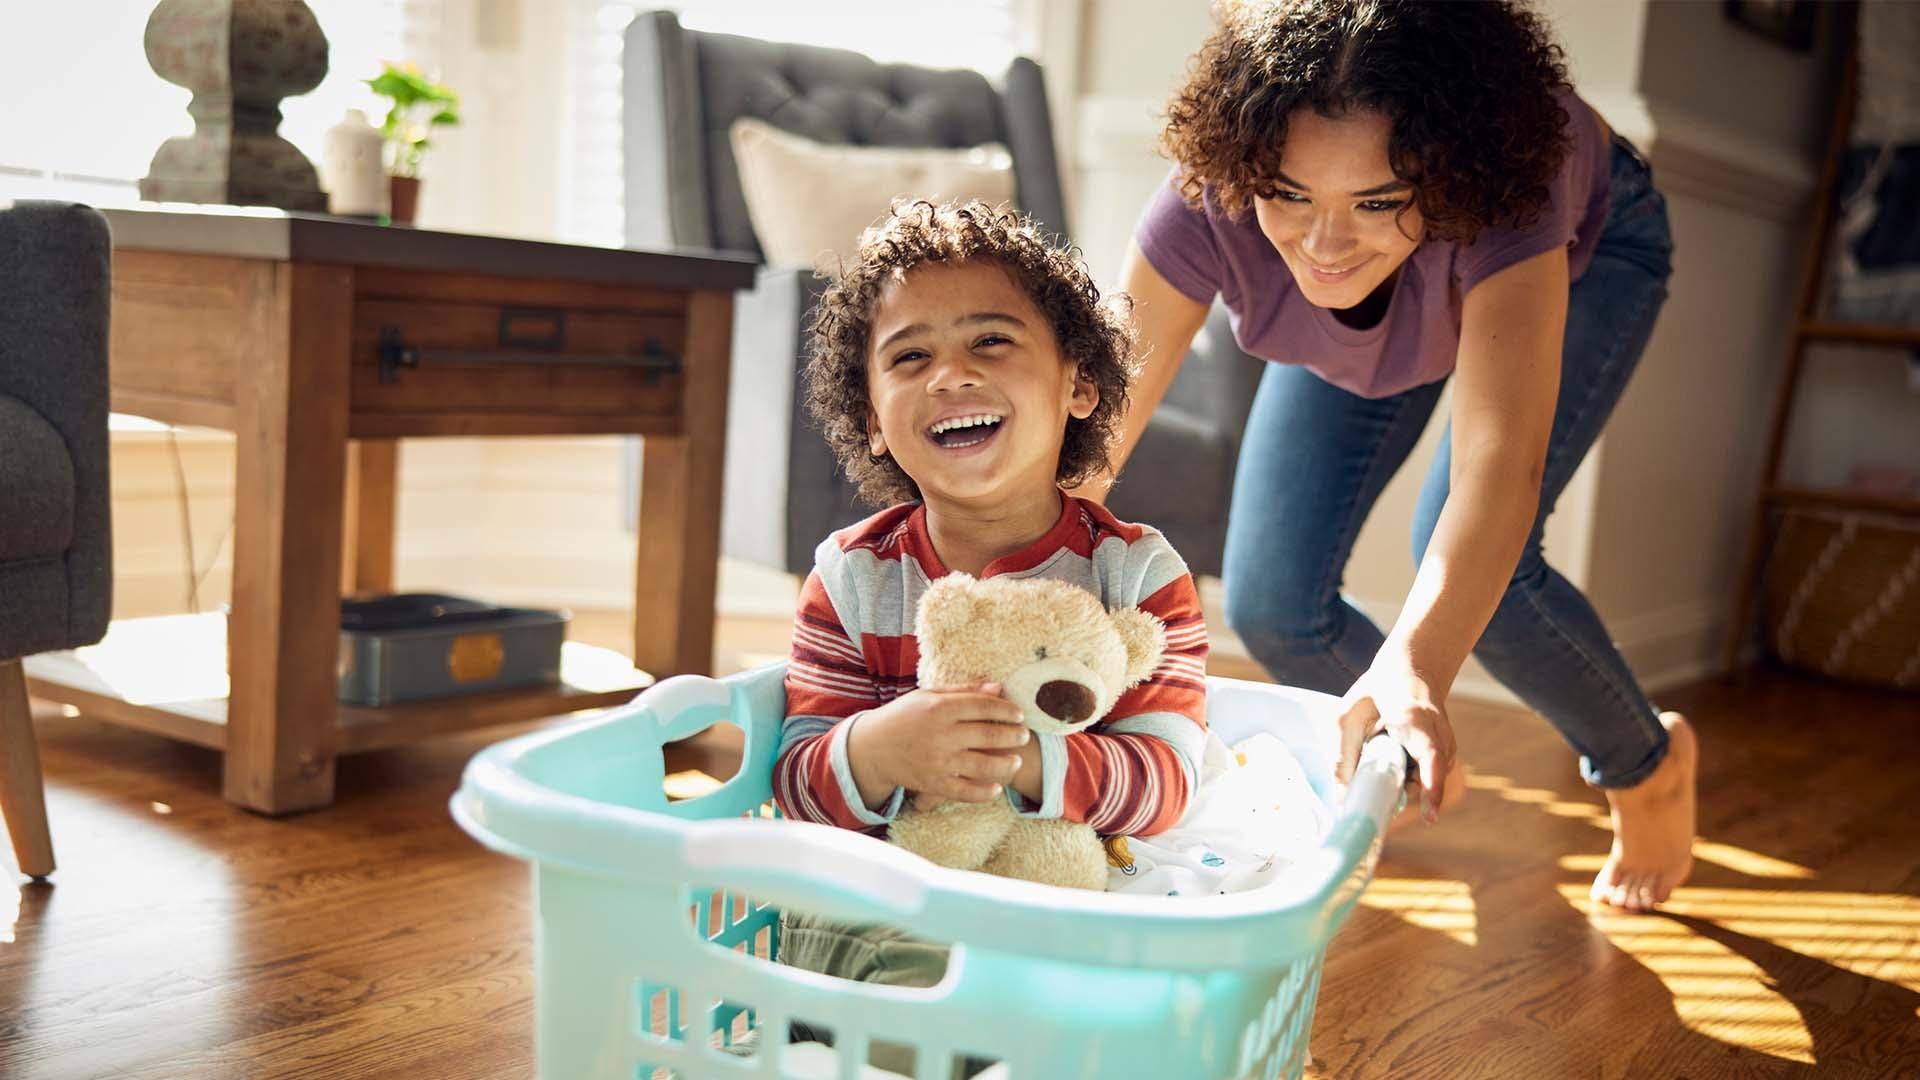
624;12;1261;575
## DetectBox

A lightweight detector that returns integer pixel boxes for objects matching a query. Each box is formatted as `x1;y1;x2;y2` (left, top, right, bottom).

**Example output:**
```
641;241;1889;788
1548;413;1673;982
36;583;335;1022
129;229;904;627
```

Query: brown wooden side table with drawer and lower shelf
27;209;753;813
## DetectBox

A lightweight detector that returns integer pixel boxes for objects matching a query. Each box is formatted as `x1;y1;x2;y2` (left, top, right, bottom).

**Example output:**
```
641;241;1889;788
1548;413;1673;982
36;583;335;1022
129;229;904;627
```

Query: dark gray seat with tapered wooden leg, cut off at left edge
0;202;113;878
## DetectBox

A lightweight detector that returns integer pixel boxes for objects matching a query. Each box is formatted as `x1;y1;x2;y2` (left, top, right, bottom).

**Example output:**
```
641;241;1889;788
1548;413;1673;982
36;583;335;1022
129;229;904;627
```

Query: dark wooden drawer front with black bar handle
351;298;685;434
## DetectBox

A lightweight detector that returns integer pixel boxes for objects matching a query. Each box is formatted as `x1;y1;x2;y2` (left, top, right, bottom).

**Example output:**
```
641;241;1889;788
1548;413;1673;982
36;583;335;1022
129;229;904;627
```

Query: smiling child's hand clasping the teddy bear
847;684;1033;809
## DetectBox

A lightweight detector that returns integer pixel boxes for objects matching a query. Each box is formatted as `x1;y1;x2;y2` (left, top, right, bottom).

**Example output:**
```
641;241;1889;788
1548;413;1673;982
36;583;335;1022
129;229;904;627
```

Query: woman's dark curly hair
1162;0;1572;244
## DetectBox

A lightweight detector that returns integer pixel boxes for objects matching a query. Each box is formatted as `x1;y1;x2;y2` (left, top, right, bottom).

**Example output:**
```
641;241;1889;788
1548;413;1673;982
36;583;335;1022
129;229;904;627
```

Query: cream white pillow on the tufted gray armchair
728;117;1014;267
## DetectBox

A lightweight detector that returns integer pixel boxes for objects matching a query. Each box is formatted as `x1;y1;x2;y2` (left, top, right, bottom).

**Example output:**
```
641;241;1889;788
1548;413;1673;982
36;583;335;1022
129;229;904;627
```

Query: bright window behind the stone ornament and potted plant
0;0;444;206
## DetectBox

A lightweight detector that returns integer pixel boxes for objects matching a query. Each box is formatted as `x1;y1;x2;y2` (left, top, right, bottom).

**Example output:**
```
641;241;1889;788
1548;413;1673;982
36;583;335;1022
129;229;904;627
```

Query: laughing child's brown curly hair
806;200;1133;505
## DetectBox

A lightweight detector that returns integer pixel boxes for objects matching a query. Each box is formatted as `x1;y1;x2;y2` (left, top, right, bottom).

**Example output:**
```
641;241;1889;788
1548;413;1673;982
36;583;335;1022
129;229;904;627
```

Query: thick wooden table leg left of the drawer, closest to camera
225;263;353;813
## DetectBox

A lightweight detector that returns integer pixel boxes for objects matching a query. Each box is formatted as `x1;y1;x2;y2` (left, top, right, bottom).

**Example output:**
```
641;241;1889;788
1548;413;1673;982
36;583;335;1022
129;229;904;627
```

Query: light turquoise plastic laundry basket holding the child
453;665;1405;1080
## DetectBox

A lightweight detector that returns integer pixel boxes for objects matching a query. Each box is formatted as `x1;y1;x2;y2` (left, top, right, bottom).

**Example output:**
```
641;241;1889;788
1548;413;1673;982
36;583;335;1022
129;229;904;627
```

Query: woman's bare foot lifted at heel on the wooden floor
1590;713;1699;911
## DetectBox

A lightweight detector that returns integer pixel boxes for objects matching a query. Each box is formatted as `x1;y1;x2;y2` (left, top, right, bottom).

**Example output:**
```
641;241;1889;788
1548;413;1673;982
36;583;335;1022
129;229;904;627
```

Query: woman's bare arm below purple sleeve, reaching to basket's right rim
1340;248;1569;819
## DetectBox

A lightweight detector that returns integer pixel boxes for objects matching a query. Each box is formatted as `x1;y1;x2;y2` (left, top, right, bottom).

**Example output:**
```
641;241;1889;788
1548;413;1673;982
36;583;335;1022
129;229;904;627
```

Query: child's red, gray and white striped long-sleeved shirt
774;496;1208;836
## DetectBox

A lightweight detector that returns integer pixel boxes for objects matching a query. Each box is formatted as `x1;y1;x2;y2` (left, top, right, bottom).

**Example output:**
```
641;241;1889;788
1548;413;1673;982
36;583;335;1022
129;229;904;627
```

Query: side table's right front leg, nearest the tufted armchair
634;292;733;678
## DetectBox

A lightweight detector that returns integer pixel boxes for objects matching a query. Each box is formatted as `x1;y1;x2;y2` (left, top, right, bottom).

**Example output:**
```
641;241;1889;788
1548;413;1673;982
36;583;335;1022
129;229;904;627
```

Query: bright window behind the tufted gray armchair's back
559;0;1041;246
